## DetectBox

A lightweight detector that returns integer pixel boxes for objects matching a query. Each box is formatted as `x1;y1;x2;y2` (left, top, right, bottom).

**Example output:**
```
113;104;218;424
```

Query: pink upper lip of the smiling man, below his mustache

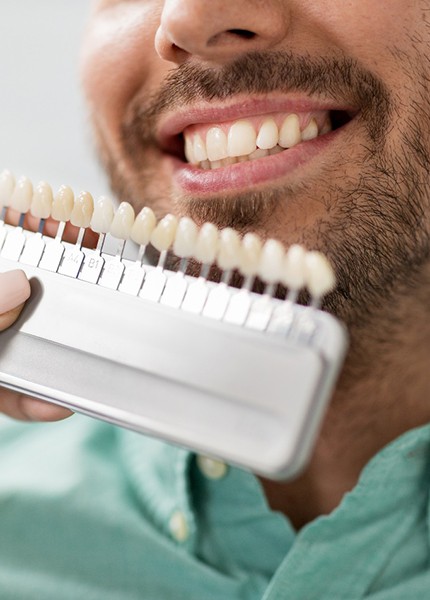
156;95;358;154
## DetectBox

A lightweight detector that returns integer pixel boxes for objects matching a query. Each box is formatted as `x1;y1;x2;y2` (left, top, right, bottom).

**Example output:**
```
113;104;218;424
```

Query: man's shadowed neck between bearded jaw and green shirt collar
262;269;430;529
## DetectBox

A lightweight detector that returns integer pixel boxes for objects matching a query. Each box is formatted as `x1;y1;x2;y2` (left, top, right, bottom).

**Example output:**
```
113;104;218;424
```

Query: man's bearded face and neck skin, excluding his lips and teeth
3;0;430;528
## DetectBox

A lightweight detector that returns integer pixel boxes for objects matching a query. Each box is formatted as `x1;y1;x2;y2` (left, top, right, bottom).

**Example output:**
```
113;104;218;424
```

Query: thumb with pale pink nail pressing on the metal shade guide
0;270;31;331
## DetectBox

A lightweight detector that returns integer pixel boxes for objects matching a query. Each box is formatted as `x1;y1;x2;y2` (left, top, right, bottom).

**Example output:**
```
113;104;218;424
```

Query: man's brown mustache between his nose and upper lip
123;51;393;143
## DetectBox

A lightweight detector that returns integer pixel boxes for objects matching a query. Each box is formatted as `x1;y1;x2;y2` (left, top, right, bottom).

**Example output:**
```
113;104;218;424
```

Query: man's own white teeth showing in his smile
184;114;330;168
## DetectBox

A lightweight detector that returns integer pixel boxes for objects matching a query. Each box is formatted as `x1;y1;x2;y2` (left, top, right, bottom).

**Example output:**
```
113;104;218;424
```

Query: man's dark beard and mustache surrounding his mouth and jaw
94;53;430;325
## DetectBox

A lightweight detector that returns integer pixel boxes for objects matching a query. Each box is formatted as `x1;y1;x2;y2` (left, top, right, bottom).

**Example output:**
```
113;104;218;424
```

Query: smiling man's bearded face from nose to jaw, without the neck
83;0;430;321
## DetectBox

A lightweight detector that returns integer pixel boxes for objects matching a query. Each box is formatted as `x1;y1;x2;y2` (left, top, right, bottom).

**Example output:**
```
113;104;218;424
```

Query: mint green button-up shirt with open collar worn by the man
0;416;430;600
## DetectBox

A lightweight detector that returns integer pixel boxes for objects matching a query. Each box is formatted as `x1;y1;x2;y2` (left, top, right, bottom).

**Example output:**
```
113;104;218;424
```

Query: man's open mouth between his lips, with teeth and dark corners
169;110;357;170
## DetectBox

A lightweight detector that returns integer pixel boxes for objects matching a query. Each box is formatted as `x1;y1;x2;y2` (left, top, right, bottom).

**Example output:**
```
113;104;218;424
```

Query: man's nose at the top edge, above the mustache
155;0;289;64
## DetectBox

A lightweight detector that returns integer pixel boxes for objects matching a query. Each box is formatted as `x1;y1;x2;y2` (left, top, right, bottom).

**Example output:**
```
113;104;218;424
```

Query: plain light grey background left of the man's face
0;0;108;196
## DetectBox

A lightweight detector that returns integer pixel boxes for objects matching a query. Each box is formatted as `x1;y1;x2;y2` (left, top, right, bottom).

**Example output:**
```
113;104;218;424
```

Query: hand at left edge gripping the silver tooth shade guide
0;271;72;421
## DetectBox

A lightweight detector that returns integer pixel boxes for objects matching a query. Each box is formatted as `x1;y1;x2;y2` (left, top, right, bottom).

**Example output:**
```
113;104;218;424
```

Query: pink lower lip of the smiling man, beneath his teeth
169;128;343;196
